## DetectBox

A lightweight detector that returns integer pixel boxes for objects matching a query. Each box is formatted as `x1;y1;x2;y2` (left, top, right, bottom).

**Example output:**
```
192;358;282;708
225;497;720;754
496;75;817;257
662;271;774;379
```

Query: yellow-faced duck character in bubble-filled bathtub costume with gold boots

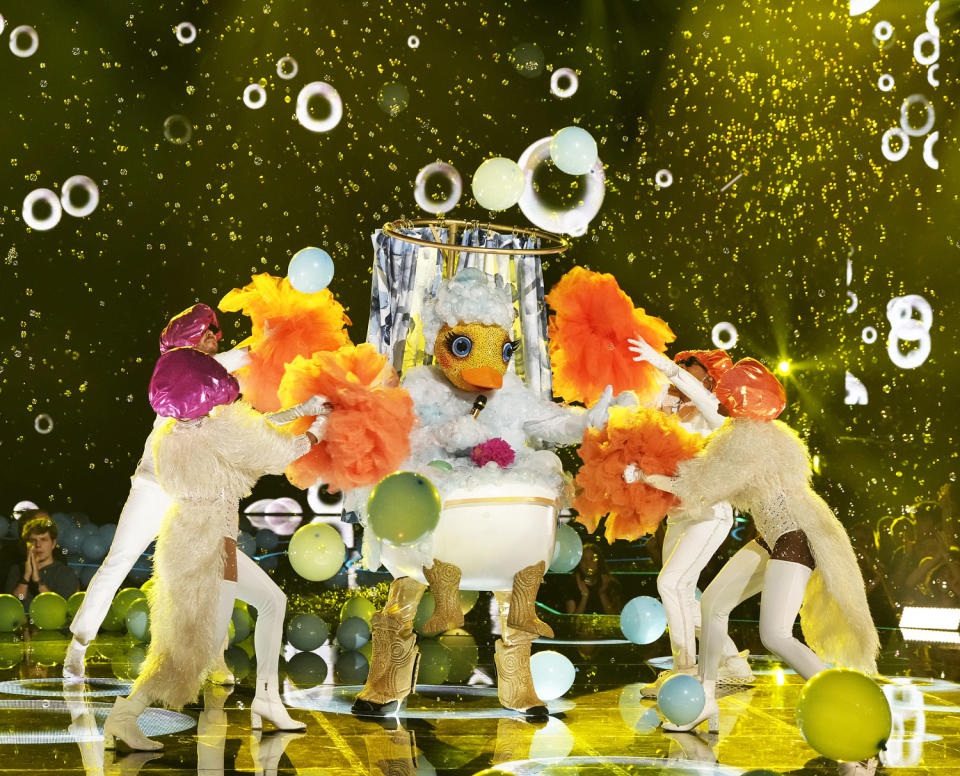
353;268;613;716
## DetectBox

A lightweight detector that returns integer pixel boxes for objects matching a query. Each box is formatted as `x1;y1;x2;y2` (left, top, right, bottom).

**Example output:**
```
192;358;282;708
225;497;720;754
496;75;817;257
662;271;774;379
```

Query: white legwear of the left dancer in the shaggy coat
210;550;287;695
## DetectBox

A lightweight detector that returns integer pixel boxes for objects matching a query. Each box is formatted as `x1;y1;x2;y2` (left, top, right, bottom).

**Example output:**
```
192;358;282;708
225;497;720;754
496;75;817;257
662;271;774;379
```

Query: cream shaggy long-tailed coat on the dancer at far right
648;418;880;674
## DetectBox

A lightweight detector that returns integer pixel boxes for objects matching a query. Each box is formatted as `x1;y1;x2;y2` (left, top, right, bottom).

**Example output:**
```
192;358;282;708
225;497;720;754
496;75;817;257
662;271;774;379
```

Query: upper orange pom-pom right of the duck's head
546;267;676;406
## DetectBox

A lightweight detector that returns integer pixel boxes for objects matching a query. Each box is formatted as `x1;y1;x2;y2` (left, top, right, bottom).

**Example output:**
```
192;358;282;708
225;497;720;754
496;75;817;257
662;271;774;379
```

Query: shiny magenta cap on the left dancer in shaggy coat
148;348;240;420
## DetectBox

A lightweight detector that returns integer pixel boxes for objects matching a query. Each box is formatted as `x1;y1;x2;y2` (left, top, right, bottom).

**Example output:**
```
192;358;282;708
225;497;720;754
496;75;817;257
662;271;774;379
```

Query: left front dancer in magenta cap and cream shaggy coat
104;347;326;749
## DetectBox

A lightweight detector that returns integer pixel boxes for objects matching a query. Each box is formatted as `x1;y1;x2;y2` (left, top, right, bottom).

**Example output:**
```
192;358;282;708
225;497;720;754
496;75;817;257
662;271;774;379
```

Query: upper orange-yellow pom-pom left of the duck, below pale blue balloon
220;273;350;412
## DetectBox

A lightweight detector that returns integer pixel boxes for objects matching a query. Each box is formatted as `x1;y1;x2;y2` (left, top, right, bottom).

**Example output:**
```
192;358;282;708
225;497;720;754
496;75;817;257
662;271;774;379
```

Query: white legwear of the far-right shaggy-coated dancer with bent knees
700;541;826;681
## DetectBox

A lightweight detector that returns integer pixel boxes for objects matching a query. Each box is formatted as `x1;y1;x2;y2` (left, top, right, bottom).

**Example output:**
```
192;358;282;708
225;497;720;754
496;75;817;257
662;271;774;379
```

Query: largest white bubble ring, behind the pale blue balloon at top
519;137;606;236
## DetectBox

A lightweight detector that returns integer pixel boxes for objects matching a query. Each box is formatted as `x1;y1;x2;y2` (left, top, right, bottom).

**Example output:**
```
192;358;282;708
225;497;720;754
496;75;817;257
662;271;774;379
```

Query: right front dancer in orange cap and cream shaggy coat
624;359;879;732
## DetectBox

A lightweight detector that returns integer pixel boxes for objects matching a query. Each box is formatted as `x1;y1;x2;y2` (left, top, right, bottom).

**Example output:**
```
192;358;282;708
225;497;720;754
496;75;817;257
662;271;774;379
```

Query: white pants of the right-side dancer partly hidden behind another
657;504;737;669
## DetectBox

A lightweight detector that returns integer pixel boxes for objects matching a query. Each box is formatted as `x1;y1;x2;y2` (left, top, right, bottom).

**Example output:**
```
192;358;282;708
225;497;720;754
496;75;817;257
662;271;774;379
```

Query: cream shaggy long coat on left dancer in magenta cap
134;402;310;709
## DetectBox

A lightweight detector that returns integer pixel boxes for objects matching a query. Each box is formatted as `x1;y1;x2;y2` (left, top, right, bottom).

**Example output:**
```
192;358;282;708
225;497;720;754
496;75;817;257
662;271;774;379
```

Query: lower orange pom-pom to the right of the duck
573;407;703;542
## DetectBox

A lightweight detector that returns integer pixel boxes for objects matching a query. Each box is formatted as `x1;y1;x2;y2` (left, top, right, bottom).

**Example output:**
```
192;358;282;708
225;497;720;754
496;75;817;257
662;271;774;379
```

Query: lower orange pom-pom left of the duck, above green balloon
280;344;416;490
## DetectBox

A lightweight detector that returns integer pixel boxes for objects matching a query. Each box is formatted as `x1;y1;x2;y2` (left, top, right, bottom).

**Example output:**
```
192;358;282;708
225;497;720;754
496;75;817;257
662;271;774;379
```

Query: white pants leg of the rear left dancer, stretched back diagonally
70;477;173;644
